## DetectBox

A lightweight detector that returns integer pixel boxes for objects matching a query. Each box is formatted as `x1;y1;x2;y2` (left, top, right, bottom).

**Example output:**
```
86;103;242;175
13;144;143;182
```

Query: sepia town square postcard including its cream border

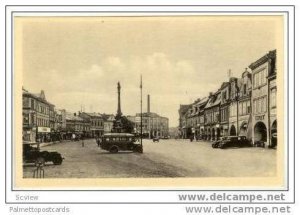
13;14;287;189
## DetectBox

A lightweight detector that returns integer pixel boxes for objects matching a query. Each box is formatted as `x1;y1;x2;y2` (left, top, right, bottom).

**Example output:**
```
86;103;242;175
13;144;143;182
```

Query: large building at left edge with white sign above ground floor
22;89;54;142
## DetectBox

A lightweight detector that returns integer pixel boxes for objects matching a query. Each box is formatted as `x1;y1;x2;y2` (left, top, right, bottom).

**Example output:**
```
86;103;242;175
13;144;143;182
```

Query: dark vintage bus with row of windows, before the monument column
100;133;143;153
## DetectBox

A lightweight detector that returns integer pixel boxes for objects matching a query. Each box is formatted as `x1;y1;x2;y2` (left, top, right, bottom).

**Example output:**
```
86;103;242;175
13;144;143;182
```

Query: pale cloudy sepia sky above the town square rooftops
16;16;282;126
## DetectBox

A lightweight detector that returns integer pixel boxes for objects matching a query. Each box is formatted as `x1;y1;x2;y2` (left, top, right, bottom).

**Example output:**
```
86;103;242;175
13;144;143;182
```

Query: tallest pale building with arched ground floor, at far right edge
249;50;277;146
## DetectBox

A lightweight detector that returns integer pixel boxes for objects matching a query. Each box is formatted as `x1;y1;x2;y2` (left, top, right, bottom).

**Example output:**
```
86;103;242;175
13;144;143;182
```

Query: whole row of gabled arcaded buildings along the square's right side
178;50;277;147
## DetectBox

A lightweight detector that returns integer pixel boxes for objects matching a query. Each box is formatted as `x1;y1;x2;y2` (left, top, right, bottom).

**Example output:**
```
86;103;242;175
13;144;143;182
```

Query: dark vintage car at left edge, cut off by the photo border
23;142;64;165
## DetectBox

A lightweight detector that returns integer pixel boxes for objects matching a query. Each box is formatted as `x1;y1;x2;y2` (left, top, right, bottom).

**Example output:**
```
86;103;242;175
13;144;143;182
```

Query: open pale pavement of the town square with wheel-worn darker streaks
23;139;277;178
